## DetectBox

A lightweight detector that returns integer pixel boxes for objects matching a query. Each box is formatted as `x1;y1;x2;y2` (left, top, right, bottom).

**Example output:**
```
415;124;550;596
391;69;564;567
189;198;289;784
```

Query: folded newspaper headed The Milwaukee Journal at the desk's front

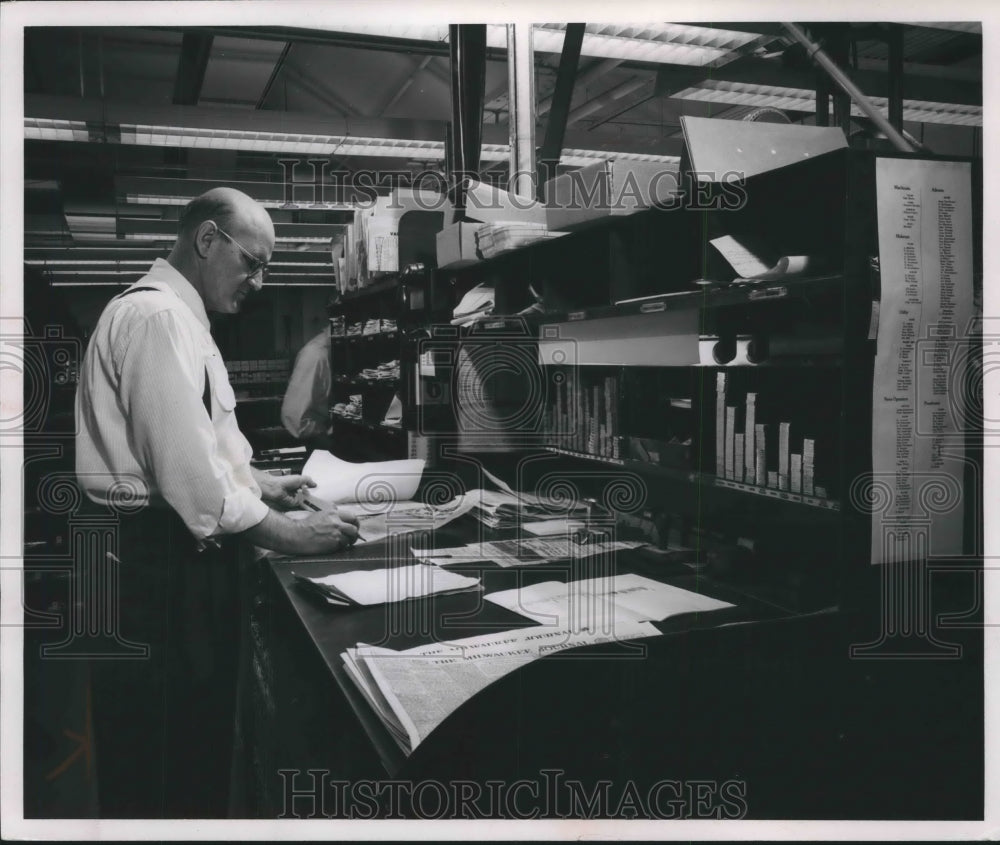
341;620;660;754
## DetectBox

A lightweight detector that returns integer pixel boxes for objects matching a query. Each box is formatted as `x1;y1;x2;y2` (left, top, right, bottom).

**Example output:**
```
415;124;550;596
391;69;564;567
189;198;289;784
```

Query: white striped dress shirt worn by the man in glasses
76;258;268;539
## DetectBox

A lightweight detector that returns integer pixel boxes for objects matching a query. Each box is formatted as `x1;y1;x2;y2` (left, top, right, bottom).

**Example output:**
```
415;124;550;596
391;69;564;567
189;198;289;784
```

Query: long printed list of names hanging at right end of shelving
872;158;973;563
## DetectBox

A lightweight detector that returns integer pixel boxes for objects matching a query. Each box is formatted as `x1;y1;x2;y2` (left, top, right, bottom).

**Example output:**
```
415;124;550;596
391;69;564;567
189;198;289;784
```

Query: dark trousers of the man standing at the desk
91;508;239;818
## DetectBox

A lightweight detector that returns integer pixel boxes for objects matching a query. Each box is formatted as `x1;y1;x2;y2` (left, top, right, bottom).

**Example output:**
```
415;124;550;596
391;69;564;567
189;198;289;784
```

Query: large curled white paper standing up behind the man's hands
302;449;425;504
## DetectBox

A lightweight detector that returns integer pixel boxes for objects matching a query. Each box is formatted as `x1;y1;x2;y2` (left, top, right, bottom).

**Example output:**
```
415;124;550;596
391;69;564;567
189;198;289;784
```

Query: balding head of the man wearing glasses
167;187;274;314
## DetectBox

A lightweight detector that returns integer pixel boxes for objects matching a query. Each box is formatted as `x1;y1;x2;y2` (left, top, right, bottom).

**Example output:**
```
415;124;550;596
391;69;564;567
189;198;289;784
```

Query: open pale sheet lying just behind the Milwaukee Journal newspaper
485;573;733;630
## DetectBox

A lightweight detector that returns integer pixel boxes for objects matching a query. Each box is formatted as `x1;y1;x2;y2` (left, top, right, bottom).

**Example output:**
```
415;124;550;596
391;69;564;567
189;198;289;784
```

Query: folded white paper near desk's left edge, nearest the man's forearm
292;563;480;607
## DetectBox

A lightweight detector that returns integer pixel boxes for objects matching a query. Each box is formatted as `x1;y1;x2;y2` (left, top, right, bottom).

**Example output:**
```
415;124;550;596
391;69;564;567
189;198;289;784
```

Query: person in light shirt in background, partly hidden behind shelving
281;328;333;450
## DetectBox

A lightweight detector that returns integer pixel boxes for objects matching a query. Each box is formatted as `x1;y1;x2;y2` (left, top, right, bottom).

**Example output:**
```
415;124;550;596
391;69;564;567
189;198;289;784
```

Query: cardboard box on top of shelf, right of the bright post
545;159;680;230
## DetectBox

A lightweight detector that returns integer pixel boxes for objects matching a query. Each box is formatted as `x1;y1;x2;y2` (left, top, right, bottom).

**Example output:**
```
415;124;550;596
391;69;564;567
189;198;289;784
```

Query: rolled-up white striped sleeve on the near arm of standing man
115;310;268;539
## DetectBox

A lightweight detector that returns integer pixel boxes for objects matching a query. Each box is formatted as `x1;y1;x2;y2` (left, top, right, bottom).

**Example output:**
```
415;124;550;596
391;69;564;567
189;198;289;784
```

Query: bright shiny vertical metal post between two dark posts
507;24;535;199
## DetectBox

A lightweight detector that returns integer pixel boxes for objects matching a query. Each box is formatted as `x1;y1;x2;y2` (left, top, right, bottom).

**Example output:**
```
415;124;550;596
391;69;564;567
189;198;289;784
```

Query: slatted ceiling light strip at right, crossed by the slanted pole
673;79;983;127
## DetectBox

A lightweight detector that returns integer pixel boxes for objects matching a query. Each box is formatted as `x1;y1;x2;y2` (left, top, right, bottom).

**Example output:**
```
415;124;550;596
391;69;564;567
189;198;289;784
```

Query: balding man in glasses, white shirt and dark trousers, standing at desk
76;188;357;818
